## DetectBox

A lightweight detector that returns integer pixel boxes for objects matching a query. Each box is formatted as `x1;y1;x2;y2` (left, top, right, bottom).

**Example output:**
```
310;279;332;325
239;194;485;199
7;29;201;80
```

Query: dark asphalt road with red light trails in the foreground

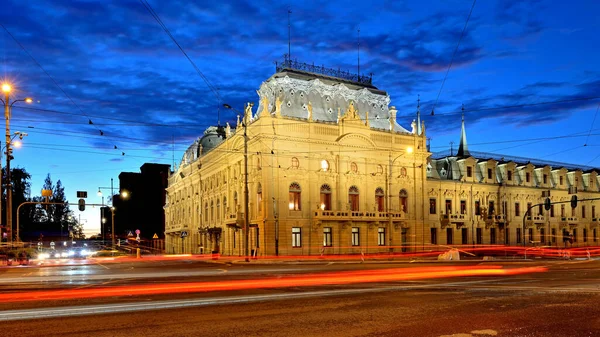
0;260;600;337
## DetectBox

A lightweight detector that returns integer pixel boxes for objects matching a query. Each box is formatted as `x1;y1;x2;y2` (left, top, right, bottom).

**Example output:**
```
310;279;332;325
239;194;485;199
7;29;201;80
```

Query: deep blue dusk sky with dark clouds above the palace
0;0;600;235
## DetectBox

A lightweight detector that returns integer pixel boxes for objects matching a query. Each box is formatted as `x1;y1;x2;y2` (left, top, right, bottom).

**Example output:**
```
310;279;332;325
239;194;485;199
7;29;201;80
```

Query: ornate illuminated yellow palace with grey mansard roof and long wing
164;59;600;256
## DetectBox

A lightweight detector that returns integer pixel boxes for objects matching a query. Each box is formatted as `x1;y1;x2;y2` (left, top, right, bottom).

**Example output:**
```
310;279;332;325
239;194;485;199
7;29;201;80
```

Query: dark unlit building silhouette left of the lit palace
112;163;170;241
